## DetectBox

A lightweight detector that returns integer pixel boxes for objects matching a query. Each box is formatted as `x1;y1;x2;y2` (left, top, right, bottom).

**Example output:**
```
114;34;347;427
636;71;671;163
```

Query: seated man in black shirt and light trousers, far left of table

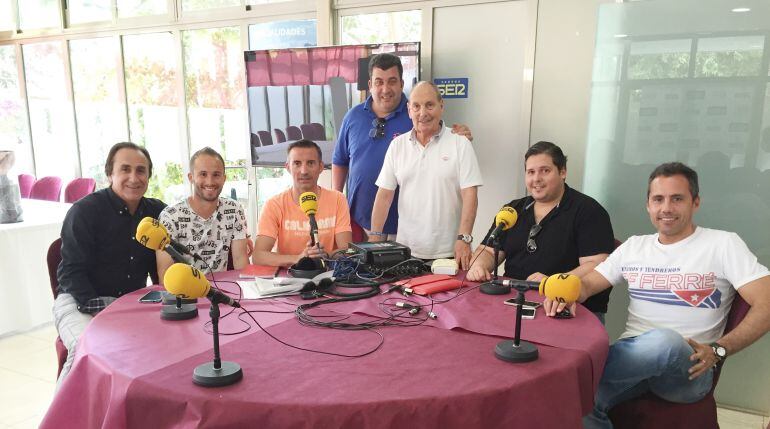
53;142;165;388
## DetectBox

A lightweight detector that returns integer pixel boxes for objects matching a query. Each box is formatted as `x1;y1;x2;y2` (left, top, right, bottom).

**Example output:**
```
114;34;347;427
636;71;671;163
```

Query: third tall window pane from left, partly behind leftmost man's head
70;37;128;188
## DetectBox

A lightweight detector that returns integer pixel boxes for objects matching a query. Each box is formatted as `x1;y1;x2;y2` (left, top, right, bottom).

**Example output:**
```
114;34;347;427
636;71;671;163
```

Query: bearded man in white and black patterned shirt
157;147;249;281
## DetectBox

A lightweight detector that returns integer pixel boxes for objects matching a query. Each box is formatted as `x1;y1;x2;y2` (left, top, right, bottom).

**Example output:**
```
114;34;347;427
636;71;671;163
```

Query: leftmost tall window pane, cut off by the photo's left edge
0;45;35;174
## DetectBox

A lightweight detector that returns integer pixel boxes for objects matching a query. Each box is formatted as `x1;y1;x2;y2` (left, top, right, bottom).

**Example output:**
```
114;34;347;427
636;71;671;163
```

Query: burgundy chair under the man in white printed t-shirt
609;294;751;429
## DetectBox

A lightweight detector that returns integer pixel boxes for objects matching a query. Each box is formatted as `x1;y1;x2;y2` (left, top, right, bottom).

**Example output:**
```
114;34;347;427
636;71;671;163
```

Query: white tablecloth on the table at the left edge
0;199;72;336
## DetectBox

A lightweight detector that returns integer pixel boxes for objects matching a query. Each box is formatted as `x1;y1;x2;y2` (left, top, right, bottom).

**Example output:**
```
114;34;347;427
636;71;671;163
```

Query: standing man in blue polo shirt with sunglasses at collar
332;54;473;241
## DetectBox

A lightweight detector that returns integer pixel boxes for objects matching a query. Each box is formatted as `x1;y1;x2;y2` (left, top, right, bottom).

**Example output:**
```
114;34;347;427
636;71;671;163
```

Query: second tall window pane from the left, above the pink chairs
22;42;78;183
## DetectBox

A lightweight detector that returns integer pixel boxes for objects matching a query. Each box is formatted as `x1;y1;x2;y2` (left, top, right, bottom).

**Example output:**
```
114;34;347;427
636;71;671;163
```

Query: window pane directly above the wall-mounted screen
340;10;422;45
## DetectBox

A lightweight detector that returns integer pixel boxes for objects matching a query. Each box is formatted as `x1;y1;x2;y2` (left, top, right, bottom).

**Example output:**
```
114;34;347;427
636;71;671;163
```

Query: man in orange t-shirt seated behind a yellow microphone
253;140;352;267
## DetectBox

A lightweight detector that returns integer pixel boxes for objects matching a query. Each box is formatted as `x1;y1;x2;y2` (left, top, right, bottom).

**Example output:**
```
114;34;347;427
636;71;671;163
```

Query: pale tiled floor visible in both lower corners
0;325;770;429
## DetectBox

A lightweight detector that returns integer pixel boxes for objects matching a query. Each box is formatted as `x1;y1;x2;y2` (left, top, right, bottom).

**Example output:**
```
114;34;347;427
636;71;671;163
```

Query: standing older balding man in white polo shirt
369;82;482;269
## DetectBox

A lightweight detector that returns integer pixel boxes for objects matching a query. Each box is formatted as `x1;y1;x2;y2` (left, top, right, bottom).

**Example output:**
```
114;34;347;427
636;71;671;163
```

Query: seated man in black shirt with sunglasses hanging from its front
467;141;615;323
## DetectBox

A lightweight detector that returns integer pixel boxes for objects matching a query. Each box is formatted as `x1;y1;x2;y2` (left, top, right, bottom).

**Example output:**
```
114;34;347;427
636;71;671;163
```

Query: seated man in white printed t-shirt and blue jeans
545;162;770;428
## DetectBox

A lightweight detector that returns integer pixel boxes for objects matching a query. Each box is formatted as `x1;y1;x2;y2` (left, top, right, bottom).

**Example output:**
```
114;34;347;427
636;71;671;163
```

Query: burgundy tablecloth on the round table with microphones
41;276;608;428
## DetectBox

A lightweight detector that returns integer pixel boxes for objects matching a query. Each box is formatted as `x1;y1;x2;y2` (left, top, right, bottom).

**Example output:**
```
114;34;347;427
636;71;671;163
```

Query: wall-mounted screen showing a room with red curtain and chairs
244;42;420;167
